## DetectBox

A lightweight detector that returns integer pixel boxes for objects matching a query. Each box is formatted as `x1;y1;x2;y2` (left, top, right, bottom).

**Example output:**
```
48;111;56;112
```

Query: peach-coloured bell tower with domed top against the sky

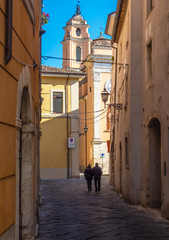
61;2;92;70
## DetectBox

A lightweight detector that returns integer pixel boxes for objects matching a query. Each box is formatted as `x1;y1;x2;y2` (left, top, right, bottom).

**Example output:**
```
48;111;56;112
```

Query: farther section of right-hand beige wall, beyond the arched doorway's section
112;1;142;202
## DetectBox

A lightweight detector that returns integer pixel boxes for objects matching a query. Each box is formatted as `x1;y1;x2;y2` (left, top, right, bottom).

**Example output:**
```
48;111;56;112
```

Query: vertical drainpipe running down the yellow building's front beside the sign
66;74;70;179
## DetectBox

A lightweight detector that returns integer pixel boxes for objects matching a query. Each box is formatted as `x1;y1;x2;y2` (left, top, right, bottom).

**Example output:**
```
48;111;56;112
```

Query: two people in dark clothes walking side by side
84;163;102;192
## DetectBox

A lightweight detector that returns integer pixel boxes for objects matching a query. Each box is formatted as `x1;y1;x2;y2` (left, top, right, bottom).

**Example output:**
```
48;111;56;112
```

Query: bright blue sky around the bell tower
42;0;117;67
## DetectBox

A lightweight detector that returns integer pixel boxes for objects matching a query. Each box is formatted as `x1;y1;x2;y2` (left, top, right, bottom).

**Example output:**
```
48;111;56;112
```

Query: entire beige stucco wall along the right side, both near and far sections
112;0;169;217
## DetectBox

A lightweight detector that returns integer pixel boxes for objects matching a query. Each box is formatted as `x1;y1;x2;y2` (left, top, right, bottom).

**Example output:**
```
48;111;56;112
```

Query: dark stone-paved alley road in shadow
38;175;169;240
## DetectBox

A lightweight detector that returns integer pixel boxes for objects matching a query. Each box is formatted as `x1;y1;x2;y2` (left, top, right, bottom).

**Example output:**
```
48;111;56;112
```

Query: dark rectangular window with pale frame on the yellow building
53;92;63;113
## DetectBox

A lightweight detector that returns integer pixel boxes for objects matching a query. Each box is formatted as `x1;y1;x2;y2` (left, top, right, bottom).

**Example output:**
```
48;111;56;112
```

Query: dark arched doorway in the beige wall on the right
148;118;161;208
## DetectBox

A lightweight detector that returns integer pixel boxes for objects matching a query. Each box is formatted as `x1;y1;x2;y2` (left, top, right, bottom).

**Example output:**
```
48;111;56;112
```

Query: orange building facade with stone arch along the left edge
0;0;41;240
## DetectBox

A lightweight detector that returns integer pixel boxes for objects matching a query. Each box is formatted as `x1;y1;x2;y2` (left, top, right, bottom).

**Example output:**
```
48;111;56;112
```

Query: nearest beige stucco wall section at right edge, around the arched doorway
142;0;169;217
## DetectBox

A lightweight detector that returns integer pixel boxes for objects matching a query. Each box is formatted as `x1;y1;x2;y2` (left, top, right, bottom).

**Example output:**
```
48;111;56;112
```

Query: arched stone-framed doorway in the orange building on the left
19;87;33;240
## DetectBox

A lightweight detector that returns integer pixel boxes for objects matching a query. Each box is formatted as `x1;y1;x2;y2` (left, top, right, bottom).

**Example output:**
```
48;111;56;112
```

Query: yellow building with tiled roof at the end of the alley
40;66;85;179
